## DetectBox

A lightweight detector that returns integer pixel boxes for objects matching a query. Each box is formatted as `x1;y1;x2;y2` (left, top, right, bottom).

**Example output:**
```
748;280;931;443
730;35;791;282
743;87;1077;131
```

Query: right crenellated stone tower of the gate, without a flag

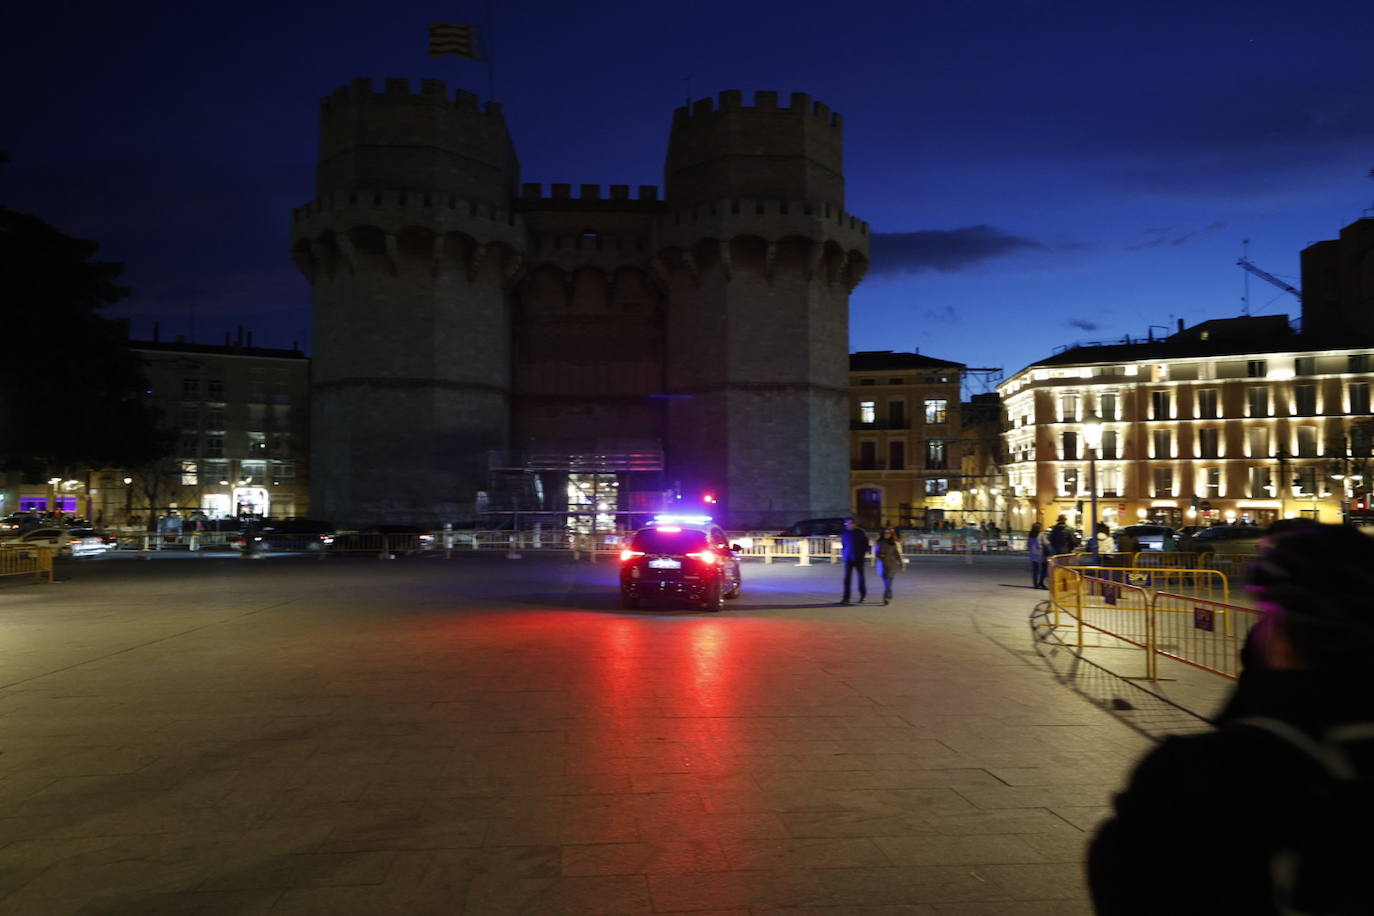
655;91;868;527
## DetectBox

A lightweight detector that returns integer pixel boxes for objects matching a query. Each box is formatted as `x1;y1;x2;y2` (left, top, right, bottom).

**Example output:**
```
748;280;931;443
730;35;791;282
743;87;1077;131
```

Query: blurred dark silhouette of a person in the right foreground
1088;522;1374;916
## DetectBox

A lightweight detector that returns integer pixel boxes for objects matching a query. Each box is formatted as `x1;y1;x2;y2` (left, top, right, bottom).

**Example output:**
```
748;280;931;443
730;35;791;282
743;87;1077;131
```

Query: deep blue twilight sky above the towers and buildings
0;0;1374;390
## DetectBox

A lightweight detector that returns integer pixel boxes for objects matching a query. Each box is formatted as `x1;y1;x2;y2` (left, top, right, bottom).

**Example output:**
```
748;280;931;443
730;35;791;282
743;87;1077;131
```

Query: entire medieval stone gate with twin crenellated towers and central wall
294;80;868;538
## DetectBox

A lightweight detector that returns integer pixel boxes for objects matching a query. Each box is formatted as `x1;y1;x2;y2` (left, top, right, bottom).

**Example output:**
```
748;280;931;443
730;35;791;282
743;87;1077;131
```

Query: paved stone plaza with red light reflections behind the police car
0;555;1210;916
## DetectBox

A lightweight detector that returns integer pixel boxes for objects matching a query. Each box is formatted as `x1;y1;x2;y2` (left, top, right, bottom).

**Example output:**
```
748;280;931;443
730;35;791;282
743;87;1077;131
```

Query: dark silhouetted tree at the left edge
0;201;172;477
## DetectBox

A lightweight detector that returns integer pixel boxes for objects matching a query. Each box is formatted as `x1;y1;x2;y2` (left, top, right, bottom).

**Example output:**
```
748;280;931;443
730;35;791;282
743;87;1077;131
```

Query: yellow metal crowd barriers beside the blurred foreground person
1041;555;1261;680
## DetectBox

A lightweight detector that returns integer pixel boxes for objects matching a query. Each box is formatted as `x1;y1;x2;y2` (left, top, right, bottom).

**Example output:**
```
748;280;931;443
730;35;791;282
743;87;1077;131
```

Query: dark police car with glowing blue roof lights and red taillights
620;515;741;611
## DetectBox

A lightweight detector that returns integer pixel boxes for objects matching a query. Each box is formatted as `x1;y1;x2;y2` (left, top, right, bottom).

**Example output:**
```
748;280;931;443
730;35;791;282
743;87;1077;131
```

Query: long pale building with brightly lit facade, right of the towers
998;316;1374;529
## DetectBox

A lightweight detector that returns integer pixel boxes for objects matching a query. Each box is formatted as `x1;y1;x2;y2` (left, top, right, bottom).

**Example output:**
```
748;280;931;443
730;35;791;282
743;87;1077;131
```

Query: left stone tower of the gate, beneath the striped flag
293;78;525;526
